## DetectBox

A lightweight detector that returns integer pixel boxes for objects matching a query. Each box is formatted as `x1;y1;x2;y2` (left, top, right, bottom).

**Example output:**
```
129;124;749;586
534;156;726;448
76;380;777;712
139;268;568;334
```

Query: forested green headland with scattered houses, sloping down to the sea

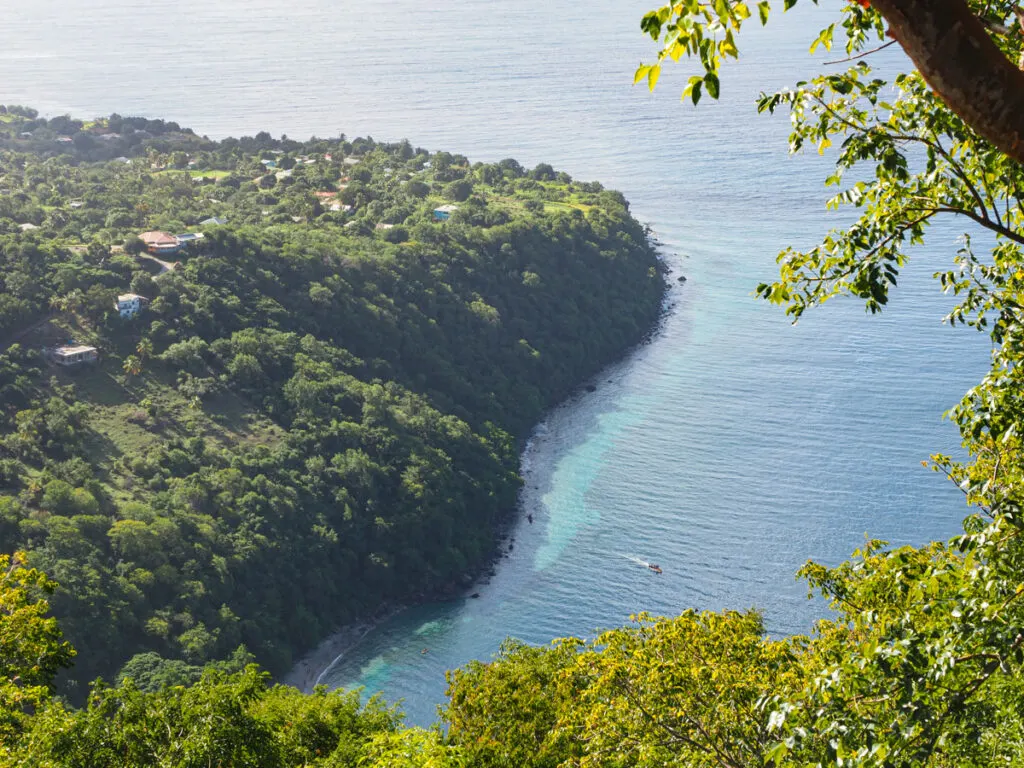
0;108;664;691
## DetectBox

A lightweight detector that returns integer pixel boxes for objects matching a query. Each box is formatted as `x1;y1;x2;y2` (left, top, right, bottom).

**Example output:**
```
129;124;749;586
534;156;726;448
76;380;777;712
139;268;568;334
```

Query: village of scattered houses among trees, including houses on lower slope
0;105;601;382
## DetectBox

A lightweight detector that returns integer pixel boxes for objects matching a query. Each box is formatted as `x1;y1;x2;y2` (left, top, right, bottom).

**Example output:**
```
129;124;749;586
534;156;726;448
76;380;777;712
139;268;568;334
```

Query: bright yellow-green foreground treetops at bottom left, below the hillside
0;553;465;768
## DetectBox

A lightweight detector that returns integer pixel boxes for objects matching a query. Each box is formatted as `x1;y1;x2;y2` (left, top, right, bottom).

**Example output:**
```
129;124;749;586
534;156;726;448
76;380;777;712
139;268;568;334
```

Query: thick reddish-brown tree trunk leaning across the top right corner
870;0;1024;164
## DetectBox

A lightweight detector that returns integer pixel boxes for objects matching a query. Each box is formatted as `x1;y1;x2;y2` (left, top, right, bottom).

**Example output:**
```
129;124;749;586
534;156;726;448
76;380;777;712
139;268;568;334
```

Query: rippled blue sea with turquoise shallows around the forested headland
0;0;988;724
